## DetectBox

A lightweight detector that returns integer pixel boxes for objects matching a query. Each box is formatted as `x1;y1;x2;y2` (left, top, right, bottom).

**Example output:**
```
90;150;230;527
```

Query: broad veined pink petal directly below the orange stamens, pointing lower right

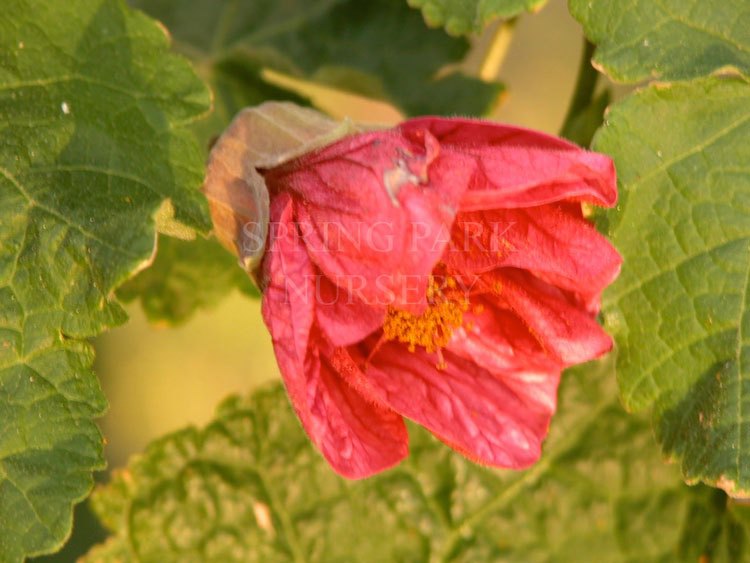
358;343;558;469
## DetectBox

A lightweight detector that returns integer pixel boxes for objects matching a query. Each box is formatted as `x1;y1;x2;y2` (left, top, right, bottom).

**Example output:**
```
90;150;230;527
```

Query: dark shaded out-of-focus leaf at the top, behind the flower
133;0;502;124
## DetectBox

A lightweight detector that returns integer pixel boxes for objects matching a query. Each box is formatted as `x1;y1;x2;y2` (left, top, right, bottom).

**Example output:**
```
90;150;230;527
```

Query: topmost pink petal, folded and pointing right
400;117;617;211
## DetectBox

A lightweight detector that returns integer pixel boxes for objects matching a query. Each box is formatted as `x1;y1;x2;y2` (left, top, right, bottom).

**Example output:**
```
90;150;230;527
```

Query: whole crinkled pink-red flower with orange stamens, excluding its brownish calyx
207;109;621;478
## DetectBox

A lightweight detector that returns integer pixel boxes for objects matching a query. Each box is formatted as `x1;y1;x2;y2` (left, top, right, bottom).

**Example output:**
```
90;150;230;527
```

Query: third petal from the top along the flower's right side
484;268;612;366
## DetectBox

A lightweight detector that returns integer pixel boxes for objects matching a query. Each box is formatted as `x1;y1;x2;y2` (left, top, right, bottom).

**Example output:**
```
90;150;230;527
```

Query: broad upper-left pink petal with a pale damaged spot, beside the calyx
264;131;470;308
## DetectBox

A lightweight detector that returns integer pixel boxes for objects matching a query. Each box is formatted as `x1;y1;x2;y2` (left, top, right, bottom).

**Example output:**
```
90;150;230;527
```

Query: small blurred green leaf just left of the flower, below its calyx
117;237;259;325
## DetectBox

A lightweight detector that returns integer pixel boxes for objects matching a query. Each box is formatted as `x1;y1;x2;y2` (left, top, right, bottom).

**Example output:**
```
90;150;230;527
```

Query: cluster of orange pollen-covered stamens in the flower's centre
383;277;469;353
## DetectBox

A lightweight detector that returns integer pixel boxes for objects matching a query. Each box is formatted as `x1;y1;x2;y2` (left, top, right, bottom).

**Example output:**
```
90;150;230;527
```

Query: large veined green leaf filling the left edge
0;0;209;561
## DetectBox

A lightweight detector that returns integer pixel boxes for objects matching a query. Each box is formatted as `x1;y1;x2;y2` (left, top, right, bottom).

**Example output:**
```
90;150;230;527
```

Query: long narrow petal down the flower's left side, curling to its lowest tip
262;195;408;478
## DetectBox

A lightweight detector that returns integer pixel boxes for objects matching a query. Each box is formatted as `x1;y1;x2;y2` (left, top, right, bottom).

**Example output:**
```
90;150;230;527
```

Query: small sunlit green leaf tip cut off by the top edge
407;0;547;35
